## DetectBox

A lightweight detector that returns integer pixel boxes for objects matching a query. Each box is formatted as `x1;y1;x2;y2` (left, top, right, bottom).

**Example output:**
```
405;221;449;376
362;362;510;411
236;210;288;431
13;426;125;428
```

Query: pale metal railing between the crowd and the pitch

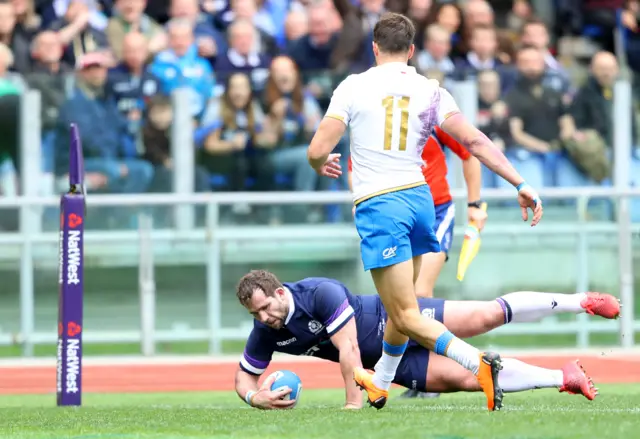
0;188;640;355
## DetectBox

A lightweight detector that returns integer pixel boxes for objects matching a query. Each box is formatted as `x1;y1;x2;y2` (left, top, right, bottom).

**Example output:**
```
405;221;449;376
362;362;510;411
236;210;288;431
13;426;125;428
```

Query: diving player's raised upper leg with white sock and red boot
440;291;620;338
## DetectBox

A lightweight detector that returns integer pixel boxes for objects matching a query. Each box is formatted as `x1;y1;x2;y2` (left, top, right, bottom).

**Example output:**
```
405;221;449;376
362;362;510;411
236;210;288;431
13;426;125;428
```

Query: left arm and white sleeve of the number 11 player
307;77;351;178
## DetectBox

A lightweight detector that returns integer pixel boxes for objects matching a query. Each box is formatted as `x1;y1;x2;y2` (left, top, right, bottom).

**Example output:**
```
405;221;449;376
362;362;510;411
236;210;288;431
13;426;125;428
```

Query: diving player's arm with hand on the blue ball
235;328;295;410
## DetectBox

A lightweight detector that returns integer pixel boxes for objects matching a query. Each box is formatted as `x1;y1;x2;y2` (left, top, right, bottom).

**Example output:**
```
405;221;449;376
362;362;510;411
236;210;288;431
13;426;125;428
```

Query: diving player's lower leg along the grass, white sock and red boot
422;354;597;400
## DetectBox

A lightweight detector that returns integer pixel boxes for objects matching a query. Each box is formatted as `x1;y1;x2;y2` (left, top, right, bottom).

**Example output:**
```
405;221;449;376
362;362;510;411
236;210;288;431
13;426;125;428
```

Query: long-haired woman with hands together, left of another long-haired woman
197;73;276;191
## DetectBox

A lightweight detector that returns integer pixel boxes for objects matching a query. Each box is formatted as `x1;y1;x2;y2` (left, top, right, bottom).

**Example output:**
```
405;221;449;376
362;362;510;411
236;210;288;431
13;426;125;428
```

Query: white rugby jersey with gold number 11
326;62;460;204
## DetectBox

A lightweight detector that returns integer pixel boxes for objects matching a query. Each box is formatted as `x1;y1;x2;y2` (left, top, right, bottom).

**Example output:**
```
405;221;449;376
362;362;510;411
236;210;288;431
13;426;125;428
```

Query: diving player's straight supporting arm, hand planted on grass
314;282;362;408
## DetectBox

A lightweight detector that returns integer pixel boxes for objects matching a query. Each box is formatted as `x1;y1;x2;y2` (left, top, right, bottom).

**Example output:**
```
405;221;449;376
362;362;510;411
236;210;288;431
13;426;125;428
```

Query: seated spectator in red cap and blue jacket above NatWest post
56;53;153;199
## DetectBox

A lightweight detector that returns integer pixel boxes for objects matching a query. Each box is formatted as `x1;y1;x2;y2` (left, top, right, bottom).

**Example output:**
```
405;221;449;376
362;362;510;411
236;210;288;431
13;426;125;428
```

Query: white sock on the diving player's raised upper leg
496;291;587;323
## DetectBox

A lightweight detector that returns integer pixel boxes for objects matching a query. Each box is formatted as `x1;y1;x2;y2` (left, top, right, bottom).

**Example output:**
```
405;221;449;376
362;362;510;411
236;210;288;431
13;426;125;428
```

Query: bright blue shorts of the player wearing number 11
355;184;440;271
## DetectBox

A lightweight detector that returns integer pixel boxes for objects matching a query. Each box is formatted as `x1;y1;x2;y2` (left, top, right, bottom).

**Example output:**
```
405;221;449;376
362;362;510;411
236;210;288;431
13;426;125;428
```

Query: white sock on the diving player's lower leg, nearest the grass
498;358;564;392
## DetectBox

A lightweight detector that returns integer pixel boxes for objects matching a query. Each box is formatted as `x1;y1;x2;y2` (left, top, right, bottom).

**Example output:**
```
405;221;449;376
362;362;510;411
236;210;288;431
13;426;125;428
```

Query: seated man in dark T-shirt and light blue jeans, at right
498;46;575;187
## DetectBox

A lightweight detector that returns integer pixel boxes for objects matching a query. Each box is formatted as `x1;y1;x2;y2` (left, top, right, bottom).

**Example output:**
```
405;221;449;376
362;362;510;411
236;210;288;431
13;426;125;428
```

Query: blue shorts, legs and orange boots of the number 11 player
354;187;502;410
